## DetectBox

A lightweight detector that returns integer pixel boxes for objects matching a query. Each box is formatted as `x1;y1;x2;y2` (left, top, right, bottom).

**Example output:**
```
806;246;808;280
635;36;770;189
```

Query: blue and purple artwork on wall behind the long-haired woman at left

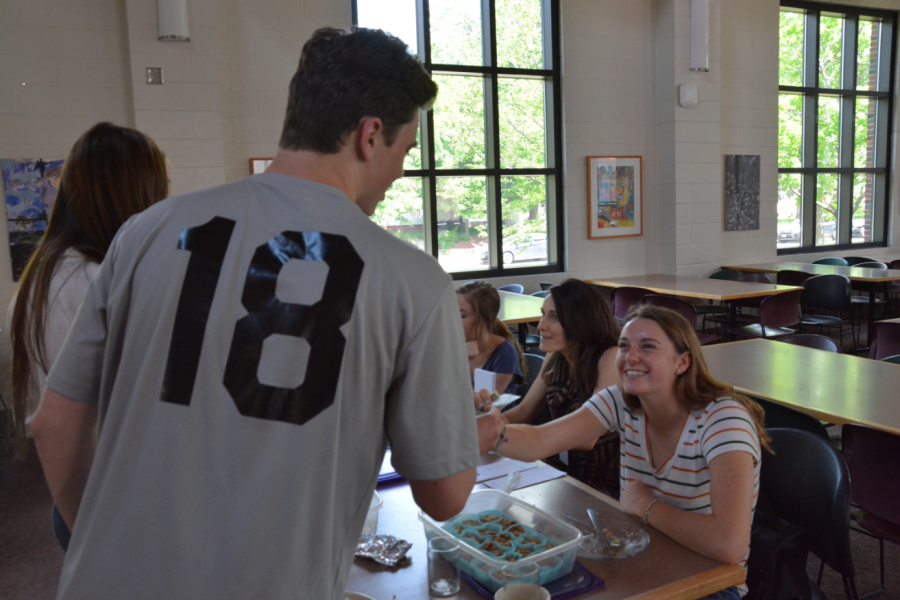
0;158;63;281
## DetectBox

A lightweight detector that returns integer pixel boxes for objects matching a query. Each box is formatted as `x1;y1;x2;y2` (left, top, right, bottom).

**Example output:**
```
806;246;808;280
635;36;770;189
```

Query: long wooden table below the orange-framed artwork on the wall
587;274;797;336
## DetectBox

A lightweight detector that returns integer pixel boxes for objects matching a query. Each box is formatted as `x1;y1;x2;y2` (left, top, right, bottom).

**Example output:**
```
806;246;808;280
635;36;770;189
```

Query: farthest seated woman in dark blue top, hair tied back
456;281;525;394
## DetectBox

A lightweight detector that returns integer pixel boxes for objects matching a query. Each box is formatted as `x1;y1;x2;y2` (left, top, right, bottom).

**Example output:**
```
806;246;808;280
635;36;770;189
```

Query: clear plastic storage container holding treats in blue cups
419;490;582;591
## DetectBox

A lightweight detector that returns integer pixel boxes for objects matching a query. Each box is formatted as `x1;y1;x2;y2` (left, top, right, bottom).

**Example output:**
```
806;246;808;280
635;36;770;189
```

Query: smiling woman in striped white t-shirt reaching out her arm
488;305;768;599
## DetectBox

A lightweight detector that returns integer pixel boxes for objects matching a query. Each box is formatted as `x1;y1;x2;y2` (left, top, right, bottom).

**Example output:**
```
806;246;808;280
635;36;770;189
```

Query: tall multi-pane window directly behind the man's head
354;0;563;279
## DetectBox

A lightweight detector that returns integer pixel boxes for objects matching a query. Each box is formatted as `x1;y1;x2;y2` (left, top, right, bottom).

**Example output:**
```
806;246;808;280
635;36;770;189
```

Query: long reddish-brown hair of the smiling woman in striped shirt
622;304;772;452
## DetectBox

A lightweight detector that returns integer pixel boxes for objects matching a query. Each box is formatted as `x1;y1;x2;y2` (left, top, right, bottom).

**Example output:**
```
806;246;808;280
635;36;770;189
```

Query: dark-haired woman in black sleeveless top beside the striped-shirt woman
476;279;619;497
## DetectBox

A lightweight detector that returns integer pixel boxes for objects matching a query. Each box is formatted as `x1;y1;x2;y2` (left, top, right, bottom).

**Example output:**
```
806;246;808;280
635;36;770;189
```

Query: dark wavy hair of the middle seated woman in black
545;279;619;392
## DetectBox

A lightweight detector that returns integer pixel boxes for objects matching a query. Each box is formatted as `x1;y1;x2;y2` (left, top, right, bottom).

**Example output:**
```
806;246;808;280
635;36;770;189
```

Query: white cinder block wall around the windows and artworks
0;0;900;389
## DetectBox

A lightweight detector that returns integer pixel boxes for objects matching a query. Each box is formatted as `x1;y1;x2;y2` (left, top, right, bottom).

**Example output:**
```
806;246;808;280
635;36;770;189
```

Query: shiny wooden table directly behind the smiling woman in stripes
703;339;900;434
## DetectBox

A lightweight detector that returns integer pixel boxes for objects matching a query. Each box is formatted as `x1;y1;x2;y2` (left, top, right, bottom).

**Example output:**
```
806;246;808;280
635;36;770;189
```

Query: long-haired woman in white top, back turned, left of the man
7;123;169;549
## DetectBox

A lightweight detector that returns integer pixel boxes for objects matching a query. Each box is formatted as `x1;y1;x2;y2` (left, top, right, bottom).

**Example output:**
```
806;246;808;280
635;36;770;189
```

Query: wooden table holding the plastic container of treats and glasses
347;477;744;600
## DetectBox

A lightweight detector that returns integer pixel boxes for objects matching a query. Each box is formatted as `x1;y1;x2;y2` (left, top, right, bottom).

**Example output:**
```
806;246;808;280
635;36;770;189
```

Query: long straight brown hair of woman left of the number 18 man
10;123;169;456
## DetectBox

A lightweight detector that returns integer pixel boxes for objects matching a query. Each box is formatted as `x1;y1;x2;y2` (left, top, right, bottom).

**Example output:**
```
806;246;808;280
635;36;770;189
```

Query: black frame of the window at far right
776;0;897;256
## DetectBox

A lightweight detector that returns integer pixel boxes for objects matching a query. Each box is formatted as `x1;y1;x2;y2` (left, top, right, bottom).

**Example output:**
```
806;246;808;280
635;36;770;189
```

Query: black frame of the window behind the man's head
352;0;565;280
